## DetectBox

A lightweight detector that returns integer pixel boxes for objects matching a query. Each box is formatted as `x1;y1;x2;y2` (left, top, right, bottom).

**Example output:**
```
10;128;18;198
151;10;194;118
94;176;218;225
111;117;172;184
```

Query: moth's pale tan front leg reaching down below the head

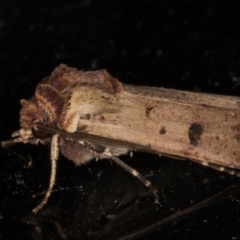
32;134;59;213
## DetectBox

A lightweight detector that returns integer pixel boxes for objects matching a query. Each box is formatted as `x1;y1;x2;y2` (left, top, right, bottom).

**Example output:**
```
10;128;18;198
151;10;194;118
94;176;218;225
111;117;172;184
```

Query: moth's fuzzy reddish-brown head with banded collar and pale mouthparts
13;82;64;142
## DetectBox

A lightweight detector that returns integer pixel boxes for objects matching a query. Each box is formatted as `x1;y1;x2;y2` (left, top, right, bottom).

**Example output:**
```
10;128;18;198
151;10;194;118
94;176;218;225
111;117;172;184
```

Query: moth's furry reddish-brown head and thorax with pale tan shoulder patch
20;64;122;132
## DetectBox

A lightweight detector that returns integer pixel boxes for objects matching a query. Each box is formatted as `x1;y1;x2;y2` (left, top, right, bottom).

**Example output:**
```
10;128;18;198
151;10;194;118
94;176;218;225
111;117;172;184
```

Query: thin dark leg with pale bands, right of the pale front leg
111;155;159;204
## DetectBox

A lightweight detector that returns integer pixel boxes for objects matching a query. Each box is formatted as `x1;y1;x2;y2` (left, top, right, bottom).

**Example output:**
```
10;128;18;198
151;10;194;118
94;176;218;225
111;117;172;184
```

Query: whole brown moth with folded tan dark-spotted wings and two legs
3;65;240;212
